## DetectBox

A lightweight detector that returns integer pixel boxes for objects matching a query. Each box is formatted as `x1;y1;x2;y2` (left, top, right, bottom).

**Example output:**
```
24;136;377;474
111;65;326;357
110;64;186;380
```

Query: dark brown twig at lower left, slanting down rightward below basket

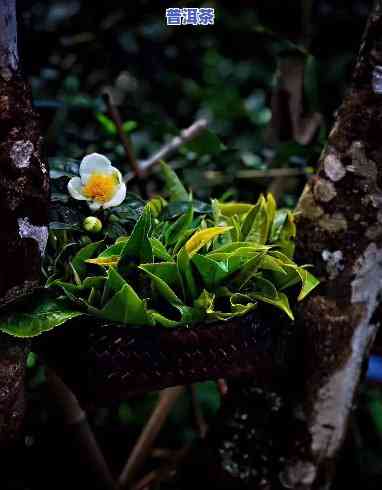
46;368;115;490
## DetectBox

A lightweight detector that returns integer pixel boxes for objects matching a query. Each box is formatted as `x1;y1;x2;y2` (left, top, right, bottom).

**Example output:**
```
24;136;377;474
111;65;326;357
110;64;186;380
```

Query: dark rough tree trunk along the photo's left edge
0;0;49;446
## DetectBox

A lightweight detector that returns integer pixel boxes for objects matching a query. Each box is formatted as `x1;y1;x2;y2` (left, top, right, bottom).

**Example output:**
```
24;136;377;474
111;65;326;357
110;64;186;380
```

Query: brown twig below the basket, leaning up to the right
117;386;184;490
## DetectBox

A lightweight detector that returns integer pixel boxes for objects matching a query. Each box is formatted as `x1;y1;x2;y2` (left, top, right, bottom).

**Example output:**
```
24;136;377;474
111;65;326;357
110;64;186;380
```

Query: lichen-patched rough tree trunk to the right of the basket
284;1;382;487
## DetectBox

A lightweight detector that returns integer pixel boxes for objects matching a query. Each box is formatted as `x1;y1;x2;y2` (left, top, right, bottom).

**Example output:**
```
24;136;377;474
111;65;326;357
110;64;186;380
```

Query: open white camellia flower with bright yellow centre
68;153;126;211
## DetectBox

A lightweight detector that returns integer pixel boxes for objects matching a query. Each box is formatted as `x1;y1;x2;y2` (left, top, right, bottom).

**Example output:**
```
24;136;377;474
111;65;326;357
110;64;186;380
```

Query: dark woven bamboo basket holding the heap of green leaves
38;307;296;402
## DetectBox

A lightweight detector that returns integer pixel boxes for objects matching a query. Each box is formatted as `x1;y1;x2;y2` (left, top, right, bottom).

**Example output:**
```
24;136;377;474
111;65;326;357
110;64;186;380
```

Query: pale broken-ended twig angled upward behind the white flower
124;119;208;183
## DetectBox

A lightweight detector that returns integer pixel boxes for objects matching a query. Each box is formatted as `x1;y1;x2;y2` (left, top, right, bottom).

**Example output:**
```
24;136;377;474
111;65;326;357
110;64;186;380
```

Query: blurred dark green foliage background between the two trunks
20;0;370;204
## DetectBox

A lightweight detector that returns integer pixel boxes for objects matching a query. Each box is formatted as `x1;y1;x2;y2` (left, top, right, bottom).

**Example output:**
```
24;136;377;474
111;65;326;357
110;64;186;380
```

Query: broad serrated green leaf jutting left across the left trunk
0;297;83;337
